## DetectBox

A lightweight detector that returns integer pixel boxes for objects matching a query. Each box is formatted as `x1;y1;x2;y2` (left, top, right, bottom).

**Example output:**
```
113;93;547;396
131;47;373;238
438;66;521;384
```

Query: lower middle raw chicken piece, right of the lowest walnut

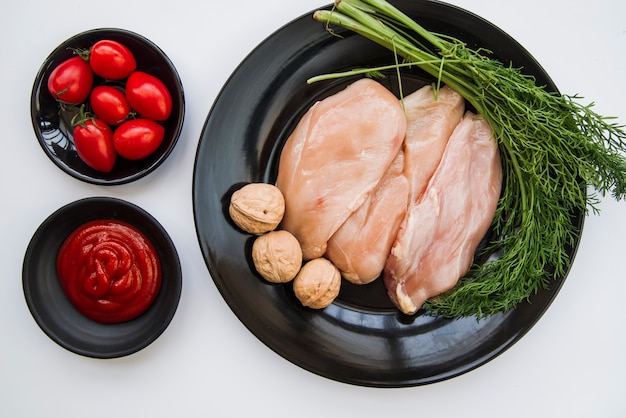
326;150;409;284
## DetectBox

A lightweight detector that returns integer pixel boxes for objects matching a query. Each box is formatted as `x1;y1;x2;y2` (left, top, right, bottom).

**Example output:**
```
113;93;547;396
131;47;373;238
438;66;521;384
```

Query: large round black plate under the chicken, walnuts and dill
193;0;583;387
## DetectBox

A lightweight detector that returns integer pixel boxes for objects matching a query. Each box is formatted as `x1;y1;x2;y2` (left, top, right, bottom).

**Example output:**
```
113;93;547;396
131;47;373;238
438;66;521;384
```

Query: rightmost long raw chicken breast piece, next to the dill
383;112;502;314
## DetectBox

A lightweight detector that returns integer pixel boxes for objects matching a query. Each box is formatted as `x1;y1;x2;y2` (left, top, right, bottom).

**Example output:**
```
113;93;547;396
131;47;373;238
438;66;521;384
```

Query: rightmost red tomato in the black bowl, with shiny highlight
126;71;172;121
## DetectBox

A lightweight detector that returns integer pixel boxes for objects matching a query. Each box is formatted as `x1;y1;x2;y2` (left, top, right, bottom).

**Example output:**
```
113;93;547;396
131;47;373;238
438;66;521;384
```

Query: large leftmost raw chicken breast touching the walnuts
276;79;406;260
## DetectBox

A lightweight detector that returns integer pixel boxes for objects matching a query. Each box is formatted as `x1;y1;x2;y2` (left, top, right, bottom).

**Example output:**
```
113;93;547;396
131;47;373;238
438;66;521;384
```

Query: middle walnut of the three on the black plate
252;230;302;283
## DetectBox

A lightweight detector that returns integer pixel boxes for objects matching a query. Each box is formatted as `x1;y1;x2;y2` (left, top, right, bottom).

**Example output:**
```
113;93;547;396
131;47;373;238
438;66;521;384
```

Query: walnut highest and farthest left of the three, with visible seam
228;183;285;234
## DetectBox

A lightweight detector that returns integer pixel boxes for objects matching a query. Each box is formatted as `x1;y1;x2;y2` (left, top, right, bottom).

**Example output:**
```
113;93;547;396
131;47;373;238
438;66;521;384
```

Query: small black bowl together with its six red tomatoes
31;28;185;185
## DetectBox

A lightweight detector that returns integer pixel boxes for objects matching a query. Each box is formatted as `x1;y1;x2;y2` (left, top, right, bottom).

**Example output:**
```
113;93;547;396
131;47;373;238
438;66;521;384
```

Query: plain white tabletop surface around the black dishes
0;0;626;418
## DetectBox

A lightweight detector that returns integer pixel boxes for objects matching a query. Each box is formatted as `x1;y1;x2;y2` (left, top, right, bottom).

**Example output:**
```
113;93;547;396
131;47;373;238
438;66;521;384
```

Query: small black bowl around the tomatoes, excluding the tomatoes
30;29;185;185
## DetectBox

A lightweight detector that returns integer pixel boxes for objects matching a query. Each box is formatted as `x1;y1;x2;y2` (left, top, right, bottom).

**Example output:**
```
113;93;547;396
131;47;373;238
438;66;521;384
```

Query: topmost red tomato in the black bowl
89;39;137;80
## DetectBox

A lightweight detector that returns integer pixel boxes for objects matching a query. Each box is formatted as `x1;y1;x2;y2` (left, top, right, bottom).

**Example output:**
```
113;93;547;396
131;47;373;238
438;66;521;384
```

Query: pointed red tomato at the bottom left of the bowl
74;119;117;173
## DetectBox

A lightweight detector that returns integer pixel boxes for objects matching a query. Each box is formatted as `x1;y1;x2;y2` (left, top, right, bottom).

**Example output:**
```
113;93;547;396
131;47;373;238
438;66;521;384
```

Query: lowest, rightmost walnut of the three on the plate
293;258;341;309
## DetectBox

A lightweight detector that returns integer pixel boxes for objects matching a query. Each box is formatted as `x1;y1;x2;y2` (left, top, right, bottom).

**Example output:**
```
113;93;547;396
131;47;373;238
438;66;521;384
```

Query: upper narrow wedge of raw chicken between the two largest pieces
404;85;465;202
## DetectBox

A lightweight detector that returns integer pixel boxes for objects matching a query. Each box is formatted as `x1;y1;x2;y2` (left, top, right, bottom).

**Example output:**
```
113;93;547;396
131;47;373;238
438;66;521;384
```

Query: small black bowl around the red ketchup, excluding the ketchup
22;197;182;358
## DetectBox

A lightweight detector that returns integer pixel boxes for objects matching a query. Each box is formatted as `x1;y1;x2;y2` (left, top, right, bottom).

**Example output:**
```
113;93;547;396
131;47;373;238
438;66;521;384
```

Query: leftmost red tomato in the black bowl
48;56;93;104
